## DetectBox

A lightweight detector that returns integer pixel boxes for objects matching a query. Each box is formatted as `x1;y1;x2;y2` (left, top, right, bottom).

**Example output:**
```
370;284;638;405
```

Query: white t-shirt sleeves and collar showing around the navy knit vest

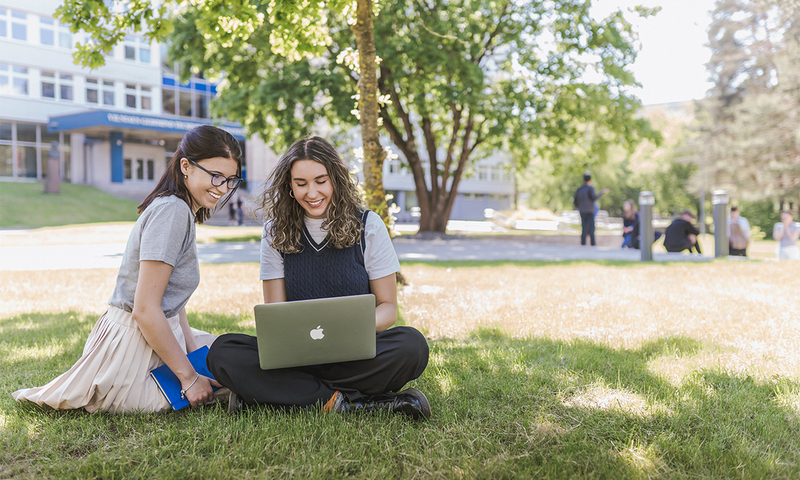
261;211;400;280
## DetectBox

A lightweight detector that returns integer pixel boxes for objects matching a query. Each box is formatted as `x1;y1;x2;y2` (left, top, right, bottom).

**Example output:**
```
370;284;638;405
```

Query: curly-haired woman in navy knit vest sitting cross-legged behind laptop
207;137;430;418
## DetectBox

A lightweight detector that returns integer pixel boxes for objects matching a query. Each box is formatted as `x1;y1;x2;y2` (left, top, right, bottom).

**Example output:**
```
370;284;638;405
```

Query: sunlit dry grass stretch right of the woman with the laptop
401;262;800;380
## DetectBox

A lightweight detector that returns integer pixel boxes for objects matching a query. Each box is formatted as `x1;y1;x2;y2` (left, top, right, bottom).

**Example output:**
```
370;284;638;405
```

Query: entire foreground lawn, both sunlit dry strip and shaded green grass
0;261;800;479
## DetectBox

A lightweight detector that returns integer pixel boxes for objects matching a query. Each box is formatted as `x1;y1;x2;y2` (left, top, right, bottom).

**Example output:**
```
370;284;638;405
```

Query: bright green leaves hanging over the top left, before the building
56;0;346;69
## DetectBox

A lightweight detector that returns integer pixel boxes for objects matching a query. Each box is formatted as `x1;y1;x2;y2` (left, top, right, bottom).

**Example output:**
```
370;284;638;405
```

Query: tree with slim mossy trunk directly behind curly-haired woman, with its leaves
57;0;389;224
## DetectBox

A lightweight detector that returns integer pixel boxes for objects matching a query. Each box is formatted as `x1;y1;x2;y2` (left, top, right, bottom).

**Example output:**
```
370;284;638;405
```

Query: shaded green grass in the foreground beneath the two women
0;314;800;478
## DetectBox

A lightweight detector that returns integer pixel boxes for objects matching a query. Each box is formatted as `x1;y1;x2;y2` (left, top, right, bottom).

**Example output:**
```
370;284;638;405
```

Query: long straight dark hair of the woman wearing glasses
138;125;242;223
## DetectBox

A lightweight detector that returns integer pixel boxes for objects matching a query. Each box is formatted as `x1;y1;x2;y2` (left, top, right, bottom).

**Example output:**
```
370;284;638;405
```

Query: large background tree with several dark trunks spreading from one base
162;0;652;232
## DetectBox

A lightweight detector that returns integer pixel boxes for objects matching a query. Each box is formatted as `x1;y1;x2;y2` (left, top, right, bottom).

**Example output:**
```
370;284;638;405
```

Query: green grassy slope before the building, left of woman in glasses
0;182;138;227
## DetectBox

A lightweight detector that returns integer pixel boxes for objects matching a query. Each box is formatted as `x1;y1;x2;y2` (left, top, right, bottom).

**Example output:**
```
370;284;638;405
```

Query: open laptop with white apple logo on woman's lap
254;294;375;370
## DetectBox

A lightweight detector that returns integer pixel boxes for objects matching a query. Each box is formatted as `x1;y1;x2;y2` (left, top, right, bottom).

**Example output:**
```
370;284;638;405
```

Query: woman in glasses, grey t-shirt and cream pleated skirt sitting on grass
12;125;242;413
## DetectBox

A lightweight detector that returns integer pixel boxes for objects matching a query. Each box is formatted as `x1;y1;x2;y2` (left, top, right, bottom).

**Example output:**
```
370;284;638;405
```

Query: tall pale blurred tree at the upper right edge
698;0;800;210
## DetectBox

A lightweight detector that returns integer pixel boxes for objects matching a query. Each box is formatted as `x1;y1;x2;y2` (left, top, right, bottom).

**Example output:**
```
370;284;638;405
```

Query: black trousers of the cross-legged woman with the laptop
206;327;428;407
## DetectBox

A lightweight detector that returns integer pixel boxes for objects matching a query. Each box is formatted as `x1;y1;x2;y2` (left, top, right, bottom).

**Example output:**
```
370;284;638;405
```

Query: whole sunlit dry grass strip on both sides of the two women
0;262;800;382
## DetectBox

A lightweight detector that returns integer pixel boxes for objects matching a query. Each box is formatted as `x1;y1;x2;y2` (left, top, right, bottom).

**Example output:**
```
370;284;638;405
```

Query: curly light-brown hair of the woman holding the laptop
259;136;366;253
